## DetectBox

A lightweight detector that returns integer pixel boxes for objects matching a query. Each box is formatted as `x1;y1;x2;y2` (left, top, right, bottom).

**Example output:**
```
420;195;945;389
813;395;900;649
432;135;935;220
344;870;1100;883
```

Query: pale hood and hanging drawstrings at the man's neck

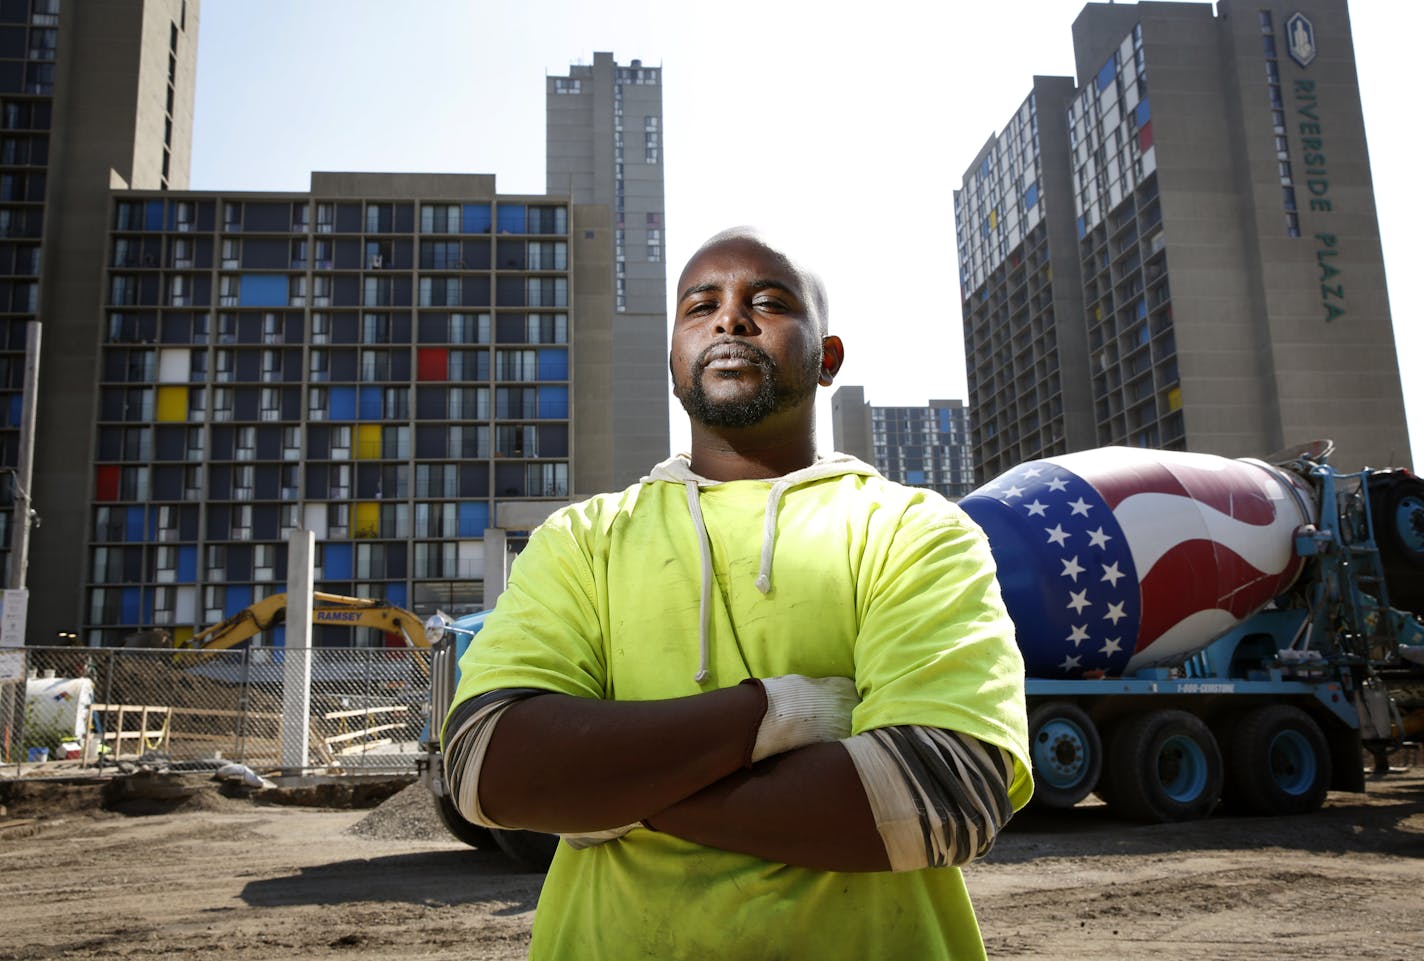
641;453;880;683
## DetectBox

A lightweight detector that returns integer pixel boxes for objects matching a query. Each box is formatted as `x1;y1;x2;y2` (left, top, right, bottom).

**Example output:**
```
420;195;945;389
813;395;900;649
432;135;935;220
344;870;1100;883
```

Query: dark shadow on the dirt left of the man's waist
242;850;544;915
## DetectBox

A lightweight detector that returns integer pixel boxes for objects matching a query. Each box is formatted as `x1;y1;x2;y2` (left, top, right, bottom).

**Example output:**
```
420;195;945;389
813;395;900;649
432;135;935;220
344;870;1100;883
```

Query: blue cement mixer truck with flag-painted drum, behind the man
424;441;1424;868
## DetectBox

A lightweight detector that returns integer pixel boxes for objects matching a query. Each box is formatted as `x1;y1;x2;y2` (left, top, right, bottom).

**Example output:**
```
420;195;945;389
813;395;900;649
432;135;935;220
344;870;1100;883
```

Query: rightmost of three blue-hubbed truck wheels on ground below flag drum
1229;705;1330;814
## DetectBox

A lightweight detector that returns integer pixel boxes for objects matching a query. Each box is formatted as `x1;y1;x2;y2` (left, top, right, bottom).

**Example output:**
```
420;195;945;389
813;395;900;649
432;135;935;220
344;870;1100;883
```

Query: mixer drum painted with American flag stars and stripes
960;447;1314;678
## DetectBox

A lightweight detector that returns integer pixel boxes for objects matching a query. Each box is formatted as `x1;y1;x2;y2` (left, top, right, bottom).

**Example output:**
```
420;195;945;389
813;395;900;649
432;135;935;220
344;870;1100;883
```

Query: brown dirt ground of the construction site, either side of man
0;767;1424;961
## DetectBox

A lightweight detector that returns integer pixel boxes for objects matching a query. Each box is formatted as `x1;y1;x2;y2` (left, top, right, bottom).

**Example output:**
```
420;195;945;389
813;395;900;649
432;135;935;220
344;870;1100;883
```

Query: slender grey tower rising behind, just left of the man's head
545;53;669;490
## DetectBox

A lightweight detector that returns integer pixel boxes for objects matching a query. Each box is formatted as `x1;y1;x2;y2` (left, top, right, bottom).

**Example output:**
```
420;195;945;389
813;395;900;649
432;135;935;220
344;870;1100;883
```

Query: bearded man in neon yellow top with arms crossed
444;229;1032;961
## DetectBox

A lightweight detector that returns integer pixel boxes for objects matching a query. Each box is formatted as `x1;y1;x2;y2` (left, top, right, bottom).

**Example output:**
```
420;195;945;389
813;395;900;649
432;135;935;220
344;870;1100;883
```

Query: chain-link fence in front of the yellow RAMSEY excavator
0;648;430;774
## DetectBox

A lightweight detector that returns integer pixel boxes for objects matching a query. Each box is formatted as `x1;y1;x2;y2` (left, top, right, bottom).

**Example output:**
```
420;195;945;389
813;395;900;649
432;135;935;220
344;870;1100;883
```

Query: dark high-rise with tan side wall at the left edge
0;0;198;642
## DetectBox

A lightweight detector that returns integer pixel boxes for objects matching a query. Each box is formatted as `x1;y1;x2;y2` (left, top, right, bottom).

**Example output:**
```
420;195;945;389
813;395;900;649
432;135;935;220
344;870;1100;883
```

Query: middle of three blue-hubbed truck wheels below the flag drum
1108;710;1223;823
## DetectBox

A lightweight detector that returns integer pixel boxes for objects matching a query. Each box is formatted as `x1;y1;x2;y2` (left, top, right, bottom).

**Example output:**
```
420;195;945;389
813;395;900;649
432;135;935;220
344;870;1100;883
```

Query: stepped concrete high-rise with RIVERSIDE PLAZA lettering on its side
956;0;1410;476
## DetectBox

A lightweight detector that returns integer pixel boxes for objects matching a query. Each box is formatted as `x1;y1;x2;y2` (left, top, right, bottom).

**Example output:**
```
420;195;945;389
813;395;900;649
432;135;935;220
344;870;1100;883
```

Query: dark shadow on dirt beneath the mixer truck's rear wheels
985;772;1424;864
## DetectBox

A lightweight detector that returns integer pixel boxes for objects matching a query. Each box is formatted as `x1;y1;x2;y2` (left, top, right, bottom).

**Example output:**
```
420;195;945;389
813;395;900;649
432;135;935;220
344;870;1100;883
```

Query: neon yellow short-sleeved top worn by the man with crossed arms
456;456;1031;961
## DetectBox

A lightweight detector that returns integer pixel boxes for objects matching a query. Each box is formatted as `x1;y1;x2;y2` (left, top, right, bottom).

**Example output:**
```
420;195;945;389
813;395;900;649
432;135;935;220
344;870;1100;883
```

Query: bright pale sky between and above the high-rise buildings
191;0;1424;469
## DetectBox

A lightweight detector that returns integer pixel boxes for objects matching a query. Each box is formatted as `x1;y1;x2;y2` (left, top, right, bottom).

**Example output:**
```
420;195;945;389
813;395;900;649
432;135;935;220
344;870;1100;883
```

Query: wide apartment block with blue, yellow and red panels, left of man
80;174;612;645
